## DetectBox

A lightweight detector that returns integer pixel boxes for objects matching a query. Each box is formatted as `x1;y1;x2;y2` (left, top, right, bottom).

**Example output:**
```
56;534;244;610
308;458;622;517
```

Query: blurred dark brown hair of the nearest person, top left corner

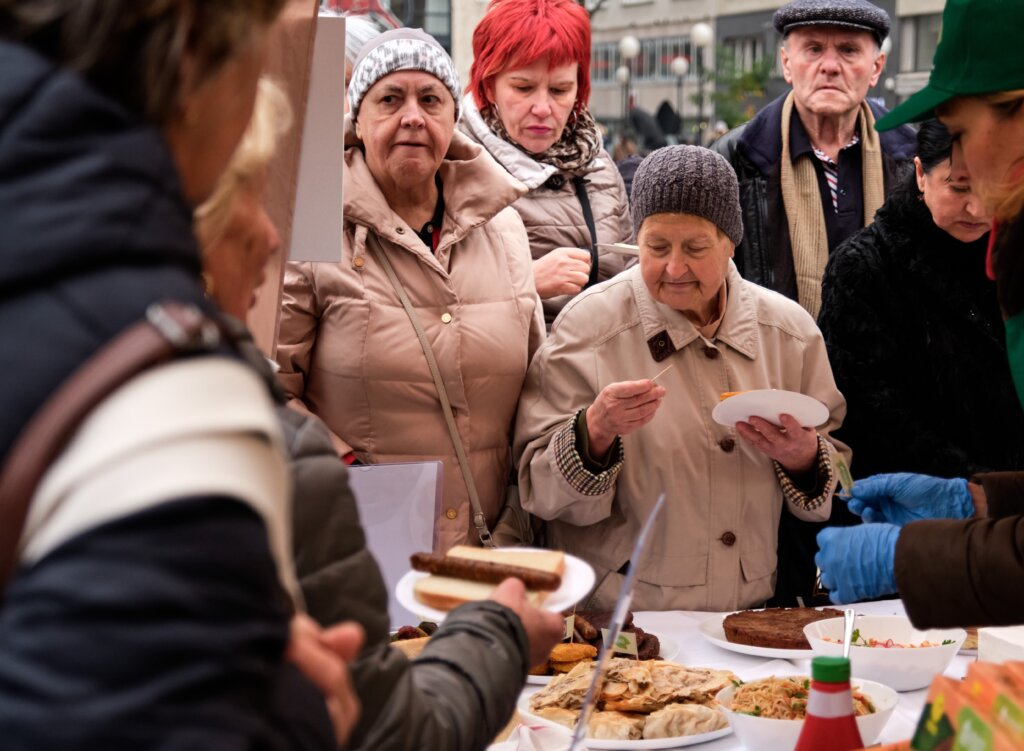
0;0;287;126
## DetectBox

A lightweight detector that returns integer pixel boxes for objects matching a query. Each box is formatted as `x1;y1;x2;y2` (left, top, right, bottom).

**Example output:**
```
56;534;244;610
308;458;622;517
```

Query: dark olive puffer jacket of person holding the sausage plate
280;407;529;751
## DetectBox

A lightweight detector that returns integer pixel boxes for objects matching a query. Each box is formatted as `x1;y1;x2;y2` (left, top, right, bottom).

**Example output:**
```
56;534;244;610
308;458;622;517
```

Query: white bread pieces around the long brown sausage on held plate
413;545;565;612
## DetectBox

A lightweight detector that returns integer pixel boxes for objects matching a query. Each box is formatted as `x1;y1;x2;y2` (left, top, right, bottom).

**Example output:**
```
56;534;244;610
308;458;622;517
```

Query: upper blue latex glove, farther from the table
847;472;974;527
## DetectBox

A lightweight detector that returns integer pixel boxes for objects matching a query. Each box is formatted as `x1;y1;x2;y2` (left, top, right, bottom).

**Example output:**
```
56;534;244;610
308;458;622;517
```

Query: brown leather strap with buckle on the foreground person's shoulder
0;303;220;598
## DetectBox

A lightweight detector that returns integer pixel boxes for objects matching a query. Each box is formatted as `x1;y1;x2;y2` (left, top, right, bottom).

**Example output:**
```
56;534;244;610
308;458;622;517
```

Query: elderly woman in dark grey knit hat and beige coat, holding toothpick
515;147;849;611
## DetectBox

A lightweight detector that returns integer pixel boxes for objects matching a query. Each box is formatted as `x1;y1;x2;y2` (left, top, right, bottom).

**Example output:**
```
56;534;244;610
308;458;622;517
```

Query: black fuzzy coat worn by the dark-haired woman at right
818;177;1024;477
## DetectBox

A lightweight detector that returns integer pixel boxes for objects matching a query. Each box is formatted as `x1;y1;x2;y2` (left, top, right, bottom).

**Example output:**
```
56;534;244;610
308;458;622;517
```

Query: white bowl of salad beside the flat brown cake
804;616;967;691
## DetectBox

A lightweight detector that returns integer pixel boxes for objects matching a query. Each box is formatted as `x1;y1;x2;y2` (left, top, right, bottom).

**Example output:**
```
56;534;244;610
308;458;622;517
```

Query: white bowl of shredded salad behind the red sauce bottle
717;676;899;751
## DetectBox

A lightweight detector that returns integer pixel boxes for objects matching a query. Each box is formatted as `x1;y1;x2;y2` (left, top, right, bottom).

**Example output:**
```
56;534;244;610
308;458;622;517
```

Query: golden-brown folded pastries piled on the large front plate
518;657;736;749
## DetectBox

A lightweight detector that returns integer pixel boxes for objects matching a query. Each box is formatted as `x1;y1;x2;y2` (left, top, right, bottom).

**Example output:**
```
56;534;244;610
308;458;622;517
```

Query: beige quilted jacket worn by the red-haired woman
459;96;636;327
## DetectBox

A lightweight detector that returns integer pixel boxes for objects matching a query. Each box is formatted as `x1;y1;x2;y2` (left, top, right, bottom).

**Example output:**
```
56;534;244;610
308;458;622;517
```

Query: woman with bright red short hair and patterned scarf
461;0;633;328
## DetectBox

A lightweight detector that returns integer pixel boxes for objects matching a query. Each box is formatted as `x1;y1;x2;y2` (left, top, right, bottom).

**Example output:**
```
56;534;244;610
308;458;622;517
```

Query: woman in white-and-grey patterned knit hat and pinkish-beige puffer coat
278;29;544;550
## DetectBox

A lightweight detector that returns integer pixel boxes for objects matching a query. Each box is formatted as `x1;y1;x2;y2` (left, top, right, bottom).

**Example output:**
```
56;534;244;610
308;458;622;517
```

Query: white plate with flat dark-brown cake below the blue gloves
697;608;843;660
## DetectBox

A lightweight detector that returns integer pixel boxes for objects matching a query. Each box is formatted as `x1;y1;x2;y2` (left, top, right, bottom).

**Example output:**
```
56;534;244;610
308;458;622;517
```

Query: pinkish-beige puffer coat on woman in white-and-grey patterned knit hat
278;128;544;550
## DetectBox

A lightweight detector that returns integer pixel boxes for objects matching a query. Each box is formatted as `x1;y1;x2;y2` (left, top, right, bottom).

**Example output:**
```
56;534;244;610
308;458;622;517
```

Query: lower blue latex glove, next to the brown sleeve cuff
814;525;899;604
